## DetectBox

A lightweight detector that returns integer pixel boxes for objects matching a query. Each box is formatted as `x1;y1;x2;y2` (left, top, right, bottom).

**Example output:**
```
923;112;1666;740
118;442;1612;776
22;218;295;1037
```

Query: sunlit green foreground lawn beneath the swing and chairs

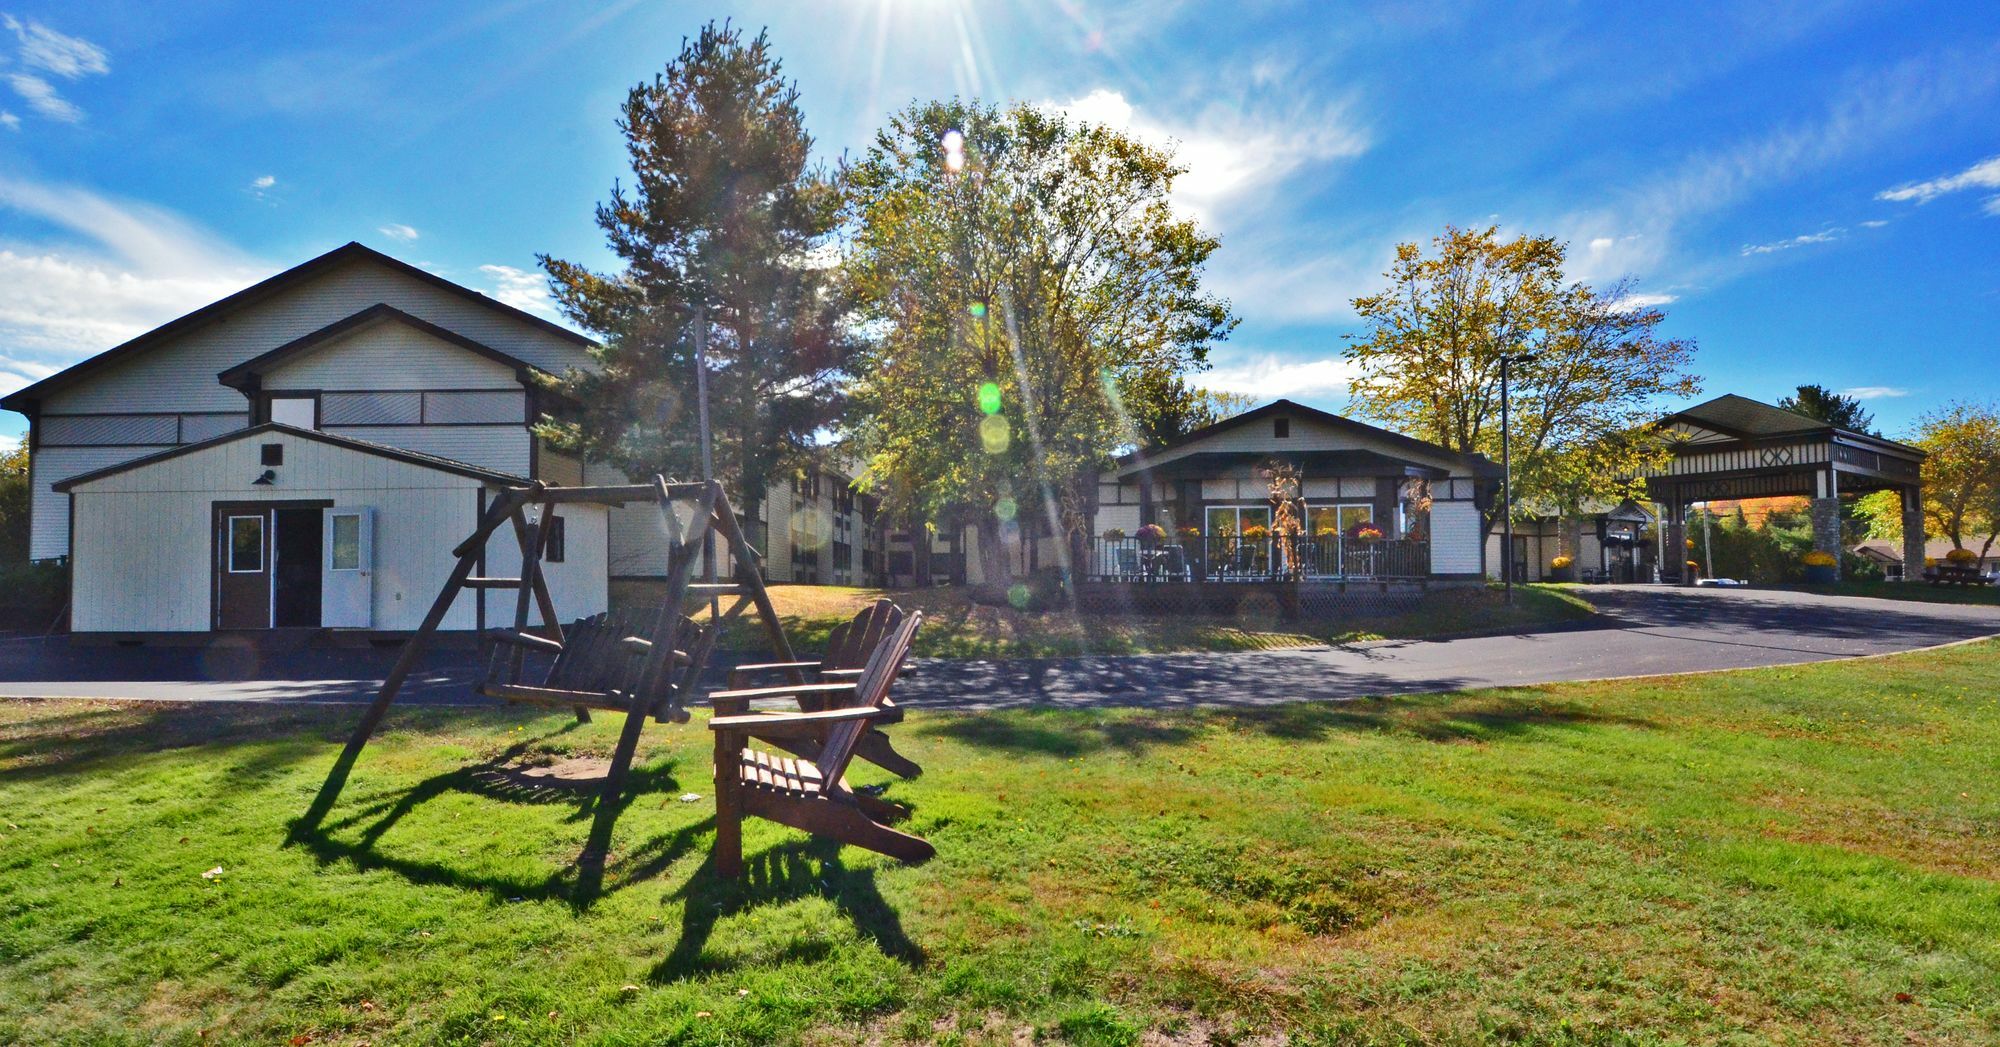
0;643;2000;1045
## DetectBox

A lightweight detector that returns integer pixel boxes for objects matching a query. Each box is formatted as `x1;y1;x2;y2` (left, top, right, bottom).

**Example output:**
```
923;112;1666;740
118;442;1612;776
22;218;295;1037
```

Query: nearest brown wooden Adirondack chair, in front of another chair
708;611;936;877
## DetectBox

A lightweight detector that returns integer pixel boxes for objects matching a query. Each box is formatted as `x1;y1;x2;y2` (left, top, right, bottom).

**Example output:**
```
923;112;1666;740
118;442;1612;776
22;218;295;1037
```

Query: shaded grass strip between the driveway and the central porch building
672;585;1592;657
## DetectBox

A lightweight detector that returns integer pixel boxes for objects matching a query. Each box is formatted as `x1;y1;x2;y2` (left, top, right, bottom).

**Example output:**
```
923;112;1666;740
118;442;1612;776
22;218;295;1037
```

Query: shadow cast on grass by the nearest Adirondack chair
648;837;924;983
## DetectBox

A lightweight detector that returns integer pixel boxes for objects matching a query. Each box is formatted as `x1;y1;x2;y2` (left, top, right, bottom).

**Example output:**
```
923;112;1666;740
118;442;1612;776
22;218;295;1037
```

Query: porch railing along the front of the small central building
1084;537;1430;583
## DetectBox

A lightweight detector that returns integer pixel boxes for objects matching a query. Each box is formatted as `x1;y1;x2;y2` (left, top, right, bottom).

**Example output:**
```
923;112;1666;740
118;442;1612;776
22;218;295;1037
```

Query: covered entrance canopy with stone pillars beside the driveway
1646;396;1924;575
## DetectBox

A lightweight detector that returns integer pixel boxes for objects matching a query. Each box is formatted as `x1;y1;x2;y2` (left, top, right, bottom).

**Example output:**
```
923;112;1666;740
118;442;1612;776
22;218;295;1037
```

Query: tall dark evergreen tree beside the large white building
542;24;852;504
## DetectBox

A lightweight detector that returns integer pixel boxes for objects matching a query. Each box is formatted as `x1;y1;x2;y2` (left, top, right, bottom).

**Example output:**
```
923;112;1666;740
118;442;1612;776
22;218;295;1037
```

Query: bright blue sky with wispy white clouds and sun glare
0;0;2000;445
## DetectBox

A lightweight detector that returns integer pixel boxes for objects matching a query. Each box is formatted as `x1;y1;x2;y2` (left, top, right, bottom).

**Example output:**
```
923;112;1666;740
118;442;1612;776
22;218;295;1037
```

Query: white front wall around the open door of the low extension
72;440;488;631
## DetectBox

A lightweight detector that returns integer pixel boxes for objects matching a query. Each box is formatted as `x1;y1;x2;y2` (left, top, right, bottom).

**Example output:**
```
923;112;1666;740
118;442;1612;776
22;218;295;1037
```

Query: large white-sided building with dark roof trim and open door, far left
0;244;616;635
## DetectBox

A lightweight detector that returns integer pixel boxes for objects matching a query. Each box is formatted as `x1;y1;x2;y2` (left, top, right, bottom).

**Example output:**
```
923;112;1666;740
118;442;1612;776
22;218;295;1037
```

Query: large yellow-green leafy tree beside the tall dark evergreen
844;102;1234;585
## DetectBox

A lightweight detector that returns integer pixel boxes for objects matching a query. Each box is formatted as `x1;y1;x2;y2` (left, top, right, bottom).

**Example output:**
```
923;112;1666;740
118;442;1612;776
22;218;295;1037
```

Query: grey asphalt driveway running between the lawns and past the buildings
0;585;2000;709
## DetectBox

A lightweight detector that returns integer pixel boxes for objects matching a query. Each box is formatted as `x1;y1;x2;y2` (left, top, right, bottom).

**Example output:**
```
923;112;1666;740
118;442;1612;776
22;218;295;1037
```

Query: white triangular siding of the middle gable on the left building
264;320;520;390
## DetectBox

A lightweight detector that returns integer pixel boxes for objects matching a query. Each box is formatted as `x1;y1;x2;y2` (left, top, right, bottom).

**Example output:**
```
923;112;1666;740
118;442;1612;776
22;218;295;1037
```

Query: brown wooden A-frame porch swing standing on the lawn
308;478;804;823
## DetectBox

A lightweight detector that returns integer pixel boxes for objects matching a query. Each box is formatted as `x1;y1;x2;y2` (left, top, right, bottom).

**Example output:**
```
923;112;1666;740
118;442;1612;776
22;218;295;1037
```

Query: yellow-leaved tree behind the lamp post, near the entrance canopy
1346;228;1700;529
